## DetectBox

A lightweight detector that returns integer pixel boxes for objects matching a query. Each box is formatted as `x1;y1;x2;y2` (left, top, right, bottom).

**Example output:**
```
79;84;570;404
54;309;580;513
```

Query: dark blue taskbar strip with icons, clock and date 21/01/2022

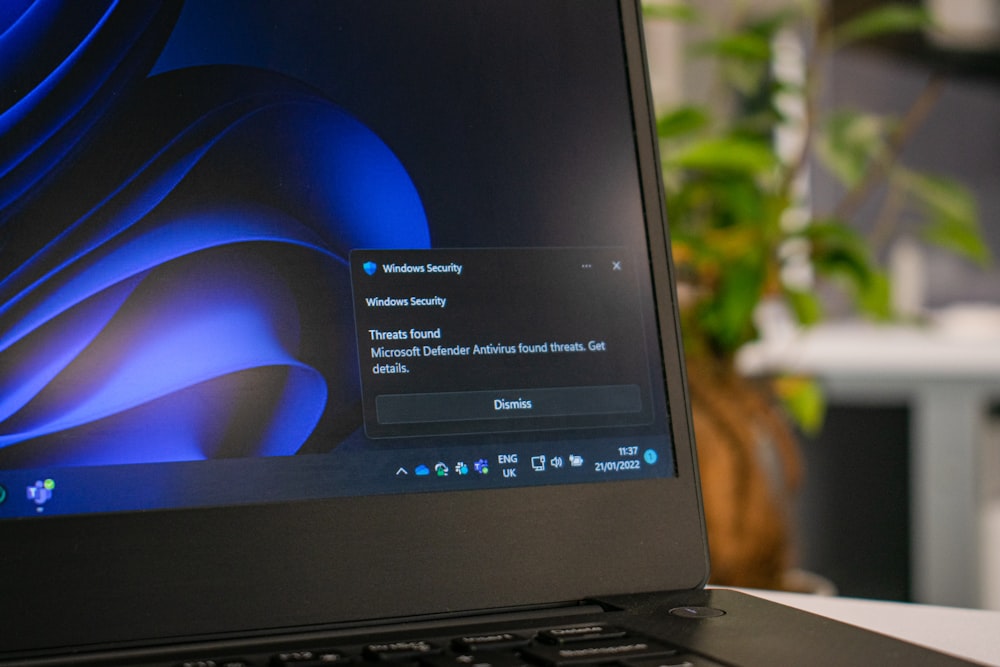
0;435;675;520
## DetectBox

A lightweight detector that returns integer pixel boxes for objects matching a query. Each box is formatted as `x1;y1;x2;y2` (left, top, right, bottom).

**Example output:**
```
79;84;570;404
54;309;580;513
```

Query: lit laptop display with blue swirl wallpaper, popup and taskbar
0;0;676;518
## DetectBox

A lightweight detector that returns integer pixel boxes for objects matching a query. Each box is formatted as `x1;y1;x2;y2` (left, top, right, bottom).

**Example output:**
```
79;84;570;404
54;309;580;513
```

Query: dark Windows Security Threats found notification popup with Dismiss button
351;248;652;437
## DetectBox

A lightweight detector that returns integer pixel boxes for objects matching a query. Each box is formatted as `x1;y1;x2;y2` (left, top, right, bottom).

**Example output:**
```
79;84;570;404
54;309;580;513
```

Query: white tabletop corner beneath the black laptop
746;590;1000;666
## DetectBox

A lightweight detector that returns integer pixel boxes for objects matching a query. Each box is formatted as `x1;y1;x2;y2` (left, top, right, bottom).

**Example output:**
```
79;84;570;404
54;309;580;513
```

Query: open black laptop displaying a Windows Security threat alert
0;0;984;667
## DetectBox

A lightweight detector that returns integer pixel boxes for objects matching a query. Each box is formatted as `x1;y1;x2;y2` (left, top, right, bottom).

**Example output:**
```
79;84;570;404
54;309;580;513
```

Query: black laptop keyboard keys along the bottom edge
175;624;718;667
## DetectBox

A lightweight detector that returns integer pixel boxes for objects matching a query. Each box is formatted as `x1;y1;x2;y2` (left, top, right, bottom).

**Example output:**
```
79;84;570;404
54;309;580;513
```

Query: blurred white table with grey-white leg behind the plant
739;314;1000;612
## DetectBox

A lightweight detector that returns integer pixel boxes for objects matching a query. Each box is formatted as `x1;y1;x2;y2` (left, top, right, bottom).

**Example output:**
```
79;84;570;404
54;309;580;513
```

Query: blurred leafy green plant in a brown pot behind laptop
647;2;989;588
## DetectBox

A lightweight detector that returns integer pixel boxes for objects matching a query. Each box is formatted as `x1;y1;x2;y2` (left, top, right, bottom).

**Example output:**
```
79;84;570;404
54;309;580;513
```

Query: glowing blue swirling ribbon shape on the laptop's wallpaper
0;0;430;469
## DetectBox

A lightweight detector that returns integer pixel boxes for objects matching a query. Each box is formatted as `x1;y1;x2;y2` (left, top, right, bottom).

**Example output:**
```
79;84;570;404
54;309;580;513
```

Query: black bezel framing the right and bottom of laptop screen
0;0;708;659
